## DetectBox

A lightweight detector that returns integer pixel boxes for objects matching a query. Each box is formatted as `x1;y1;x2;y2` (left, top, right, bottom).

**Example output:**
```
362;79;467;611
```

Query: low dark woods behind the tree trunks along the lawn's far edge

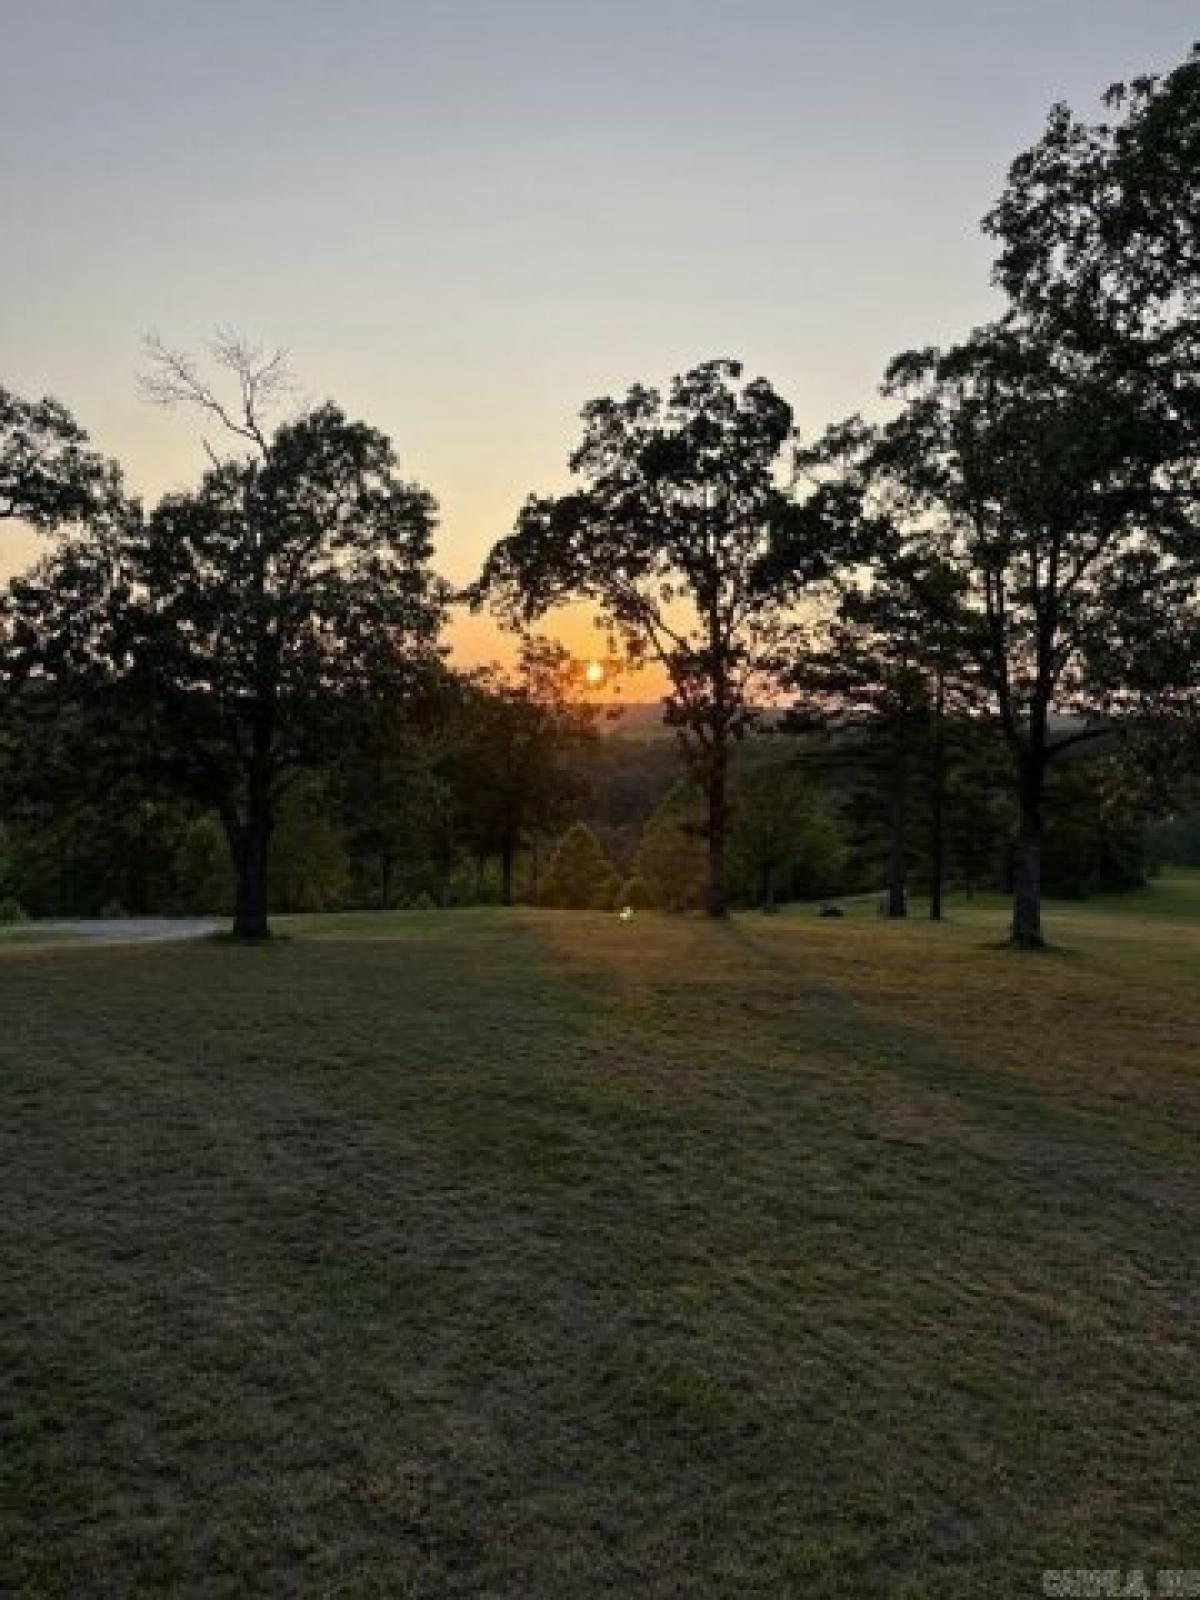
0;691;1158;920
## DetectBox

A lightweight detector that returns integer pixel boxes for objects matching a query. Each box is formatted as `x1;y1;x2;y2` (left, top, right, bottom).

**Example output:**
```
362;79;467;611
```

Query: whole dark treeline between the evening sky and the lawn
0;43;1200;946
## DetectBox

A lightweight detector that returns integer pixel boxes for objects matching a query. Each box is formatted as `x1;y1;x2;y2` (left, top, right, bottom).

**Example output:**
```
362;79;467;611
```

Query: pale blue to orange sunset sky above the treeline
0;0;1200;661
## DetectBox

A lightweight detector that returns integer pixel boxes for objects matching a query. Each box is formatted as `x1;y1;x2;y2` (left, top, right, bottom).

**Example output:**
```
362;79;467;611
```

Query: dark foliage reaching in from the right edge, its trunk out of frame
984;45;1200;902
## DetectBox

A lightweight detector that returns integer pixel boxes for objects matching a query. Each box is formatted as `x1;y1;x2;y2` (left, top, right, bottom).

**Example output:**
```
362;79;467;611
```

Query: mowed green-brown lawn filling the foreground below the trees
0;880;1200;1600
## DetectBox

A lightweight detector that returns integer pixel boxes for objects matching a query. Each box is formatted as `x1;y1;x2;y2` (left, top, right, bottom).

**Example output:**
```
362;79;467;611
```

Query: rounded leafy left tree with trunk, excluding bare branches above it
140;405;440;938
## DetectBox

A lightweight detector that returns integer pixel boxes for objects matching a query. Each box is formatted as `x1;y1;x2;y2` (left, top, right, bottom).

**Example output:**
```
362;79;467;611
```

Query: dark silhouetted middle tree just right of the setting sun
475;360;826;915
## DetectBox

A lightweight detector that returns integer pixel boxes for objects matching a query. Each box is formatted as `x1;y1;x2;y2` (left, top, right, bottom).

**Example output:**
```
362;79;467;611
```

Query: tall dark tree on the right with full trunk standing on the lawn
809;318;1173;947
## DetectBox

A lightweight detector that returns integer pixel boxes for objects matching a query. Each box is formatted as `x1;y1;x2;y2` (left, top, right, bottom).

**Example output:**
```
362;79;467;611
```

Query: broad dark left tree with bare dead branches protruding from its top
8;342;445;939
